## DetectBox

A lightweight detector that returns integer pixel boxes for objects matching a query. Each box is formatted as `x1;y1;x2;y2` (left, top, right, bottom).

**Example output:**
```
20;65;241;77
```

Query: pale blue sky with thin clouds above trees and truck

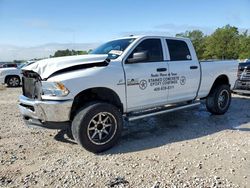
0;0;250;61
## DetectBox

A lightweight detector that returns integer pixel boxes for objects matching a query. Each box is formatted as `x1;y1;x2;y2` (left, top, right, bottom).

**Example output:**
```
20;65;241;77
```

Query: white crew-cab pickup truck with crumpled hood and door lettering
19;36;238;152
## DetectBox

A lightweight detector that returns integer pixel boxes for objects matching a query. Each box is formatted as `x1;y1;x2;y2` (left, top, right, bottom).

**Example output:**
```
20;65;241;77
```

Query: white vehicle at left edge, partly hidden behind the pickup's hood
0;61;34;87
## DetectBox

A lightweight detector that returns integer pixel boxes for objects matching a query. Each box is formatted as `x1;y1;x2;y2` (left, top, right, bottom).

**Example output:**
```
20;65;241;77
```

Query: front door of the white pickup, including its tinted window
124;38;168;111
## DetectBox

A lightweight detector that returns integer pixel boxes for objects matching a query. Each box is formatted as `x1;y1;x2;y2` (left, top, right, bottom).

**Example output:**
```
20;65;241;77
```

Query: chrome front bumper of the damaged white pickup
19;95;73;129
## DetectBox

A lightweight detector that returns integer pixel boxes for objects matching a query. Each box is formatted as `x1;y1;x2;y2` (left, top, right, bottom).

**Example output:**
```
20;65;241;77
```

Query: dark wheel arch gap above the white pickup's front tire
70;87;123;120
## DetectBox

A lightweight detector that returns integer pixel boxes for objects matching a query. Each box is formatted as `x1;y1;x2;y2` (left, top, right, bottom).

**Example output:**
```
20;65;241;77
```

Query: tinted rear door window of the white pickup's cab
166;39;192;61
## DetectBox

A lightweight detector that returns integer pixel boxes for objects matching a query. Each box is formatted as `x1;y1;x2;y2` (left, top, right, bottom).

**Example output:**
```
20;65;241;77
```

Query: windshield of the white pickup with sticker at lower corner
91;38;135;59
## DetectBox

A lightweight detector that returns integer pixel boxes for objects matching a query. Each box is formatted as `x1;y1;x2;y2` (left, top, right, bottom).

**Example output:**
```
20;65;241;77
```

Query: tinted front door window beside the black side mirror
128;39;163;63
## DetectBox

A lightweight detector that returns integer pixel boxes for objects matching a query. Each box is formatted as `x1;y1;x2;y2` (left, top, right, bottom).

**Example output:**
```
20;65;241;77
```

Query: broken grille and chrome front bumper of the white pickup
19;70;73;129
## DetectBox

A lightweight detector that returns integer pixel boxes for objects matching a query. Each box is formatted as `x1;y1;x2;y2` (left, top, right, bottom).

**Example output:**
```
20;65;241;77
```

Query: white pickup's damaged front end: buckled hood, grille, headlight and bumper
19;55;109;129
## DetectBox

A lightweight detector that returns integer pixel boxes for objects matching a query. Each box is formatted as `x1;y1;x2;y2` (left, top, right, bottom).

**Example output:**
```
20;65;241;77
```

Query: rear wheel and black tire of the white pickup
206;85;231;115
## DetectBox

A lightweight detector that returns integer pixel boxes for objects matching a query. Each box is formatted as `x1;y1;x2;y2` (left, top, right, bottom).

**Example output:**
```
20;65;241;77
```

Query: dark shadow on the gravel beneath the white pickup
55;95;250;155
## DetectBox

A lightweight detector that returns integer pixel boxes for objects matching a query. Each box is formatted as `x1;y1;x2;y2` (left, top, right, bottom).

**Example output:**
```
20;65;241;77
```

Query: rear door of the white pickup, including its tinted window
165;39;200;103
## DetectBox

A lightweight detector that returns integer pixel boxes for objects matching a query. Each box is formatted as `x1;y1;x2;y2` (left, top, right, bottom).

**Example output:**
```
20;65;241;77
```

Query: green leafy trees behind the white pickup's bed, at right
176;25;250;59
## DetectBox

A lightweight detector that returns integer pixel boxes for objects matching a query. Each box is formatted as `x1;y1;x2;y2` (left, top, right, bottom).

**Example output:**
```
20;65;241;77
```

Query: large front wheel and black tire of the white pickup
71;102;123;153
